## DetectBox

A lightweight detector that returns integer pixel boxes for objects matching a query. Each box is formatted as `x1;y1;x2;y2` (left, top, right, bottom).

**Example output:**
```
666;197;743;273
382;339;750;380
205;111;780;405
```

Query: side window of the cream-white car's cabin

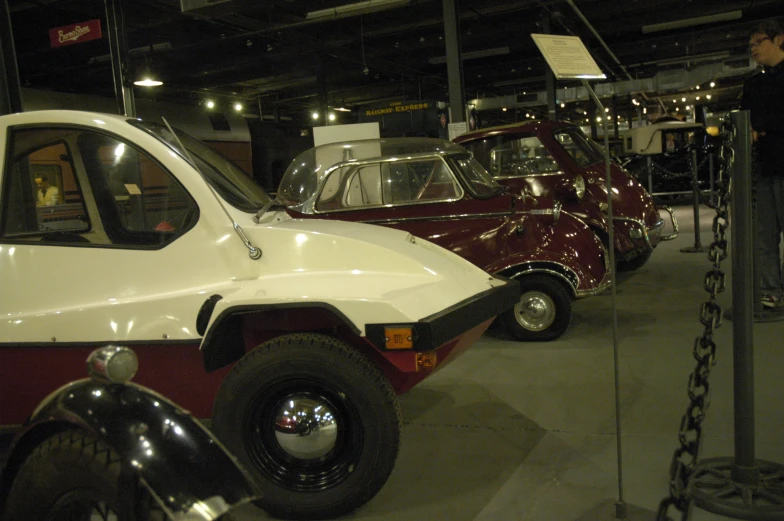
2;128;198;247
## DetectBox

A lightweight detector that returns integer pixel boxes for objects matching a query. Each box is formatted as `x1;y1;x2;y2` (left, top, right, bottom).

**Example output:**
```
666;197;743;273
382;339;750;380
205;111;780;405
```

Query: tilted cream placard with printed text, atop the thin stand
531;34;607;80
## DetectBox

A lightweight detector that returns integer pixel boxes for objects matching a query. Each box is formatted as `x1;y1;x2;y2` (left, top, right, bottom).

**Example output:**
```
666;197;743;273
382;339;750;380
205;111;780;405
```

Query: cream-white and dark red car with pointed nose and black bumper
0;111;519;519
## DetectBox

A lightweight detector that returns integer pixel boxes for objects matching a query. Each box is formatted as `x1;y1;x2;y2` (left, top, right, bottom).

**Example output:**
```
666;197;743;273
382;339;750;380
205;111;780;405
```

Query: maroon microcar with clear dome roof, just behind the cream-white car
277;138;610;340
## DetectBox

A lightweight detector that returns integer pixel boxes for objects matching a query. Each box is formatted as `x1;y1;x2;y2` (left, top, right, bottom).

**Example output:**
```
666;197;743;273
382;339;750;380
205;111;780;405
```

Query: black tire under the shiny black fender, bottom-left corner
3;430;167;521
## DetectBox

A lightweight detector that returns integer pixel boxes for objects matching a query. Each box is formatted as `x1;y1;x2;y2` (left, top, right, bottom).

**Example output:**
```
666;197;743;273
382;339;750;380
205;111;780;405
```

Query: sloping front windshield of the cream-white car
131;120;271;213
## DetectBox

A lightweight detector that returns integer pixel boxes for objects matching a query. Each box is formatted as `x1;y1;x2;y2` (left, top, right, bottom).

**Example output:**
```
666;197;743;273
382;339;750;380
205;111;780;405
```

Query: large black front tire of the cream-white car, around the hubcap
213;333;402;519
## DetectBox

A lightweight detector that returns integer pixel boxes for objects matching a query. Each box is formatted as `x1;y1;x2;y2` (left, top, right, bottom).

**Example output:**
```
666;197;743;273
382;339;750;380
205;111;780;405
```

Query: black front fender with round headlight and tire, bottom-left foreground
0;346;260;521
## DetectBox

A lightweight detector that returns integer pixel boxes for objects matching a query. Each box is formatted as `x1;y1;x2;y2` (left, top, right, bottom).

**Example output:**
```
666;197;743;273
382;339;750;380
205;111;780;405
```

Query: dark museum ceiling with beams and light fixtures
7;0;784;124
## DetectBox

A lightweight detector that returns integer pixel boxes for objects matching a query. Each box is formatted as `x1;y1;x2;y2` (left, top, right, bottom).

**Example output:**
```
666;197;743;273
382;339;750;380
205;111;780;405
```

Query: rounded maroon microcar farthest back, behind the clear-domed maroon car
454;121;678;271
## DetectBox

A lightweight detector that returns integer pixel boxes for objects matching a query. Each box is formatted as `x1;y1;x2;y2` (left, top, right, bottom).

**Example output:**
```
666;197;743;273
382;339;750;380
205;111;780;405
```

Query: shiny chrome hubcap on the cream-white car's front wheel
275;394;338;459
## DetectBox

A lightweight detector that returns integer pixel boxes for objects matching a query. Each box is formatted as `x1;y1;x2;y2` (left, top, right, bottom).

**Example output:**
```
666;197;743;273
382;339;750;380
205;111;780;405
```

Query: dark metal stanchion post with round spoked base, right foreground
689;111;784;520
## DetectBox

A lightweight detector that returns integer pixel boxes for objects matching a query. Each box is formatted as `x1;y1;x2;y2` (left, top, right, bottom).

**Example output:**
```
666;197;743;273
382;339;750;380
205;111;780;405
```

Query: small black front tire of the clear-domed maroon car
501;273;572;342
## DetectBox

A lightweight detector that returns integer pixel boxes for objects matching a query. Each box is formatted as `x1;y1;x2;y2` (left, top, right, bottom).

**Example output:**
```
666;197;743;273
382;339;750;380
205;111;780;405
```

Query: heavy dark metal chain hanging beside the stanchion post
656;121;734;521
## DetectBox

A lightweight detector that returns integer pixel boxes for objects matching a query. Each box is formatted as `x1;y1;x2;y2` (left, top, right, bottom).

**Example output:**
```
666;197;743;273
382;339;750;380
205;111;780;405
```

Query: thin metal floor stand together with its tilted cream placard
531;34;628;519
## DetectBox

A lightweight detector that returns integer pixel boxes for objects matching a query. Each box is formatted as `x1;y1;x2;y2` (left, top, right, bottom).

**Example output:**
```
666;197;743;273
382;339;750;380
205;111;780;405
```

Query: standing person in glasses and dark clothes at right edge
741;20;784;308
